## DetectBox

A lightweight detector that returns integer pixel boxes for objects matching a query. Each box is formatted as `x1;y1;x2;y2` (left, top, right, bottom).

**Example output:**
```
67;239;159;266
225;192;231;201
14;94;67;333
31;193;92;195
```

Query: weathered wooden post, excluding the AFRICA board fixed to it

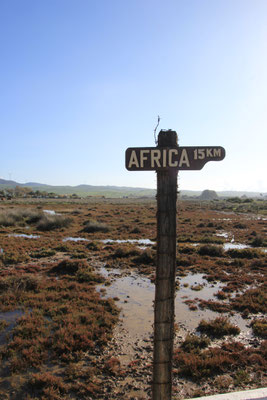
152;131;178;400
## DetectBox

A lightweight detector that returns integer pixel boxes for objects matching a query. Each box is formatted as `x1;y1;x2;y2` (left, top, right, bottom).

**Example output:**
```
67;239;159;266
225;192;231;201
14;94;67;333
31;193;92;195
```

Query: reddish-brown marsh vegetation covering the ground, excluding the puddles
0;199;267;400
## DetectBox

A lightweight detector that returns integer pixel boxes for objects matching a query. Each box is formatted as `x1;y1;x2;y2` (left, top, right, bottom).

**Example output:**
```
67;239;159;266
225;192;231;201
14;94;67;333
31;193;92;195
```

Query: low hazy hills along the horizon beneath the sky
0;179;267;198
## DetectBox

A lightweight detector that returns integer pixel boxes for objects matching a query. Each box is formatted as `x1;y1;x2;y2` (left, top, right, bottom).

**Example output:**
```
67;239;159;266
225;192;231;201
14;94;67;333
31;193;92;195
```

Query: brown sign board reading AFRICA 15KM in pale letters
125;146;225;171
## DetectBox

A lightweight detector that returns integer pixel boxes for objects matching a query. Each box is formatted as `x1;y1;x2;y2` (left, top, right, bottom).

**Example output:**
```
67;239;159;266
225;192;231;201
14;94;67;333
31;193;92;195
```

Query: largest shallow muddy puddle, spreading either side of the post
98;267;231;338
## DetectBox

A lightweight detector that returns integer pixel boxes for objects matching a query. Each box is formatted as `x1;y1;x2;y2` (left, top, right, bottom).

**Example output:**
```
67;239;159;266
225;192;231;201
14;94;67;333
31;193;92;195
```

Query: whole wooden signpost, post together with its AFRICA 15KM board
125;130;225;400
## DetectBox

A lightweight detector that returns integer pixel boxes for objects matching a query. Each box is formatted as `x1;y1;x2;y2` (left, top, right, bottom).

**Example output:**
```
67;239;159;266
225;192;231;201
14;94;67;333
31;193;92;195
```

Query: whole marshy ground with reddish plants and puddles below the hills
0;198;267;400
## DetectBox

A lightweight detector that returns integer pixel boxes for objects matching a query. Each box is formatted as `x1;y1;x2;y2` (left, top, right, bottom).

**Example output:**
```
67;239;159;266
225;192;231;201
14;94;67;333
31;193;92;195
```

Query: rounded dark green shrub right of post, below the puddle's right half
197;317;240;338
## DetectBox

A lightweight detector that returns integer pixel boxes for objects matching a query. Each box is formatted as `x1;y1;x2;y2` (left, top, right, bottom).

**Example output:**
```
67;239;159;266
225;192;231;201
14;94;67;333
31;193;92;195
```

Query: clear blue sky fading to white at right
0;0;267;192
